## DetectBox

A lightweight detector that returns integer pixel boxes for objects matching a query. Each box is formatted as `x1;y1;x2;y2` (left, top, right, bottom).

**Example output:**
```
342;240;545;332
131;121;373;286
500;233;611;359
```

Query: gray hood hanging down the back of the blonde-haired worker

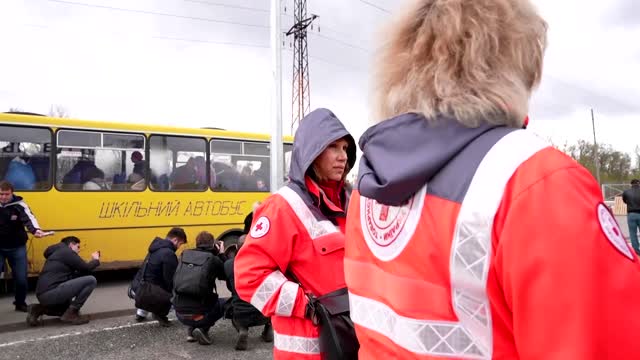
358;113;496;206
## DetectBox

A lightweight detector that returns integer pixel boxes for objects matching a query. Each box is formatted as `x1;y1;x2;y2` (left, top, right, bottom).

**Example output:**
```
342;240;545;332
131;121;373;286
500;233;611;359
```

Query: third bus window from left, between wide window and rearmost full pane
149;135;207;191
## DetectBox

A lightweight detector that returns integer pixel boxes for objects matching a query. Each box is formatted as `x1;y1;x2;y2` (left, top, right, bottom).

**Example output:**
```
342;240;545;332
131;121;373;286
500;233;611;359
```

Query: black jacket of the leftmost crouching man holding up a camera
36;243;100;296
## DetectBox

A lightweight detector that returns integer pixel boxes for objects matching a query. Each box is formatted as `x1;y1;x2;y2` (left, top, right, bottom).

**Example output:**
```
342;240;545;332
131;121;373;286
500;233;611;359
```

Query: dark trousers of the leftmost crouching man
38;275;98;309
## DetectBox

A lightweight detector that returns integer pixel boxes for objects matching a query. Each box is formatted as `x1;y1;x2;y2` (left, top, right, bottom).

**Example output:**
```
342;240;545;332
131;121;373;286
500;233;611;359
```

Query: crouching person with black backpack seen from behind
173;231;228;345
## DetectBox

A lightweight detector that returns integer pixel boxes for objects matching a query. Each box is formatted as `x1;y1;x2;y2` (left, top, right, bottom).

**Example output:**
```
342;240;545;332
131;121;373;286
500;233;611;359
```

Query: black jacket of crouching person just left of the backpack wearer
136;237;178;292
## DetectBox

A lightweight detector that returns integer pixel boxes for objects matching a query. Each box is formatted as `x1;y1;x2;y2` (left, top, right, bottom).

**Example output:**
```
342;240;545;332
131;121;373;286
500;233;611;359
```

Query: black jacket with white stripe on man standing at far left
0;195;40;249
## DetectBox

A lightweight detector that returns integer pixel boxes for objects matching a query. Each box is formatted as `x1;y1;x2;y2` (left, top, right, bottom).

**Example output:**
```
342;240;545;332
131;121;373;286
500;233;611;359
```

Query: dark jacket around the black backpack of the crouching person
173;247;227;314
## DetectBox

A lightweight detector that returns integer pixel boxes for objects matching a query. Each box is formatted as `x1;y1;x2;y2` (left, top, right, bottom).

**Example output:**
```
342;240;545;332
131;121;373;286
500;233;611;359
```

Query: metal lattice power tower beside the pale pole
287;0;318;134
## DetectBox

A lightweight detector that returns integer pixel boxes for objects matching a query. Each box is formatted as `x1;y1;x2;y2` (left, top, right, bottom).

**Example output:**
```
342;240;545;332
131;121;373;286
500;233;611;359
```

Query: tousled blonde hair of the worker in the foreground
373;0;547;127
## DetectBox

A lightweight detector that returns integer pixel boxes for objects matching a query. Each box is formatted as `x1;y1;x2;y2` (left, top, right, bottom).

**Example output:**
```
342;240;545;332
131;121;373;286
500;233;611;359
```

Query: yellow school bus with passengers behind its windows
0;113;293;276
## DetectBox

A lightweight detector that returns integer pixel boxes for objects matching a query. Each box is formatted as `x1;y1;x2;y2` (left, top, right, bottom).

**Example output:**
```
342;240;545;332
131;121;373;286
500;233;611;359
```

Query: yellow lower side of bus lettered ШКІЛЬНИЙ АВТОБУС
24;189;269;275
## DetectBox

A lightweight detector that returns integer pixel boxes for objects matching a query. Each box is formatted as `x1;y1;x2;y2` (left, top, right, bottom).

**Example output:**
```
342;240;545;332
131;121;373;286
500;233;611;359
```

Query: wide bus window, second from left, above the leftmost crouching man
56;130;146;191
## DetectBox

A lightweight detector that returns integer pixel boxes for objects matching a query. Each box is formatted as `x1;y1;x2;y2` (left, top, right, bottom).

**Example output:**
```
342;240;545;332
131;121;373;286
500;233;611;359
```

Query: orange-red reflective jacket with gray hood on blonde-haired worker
345;114;640;360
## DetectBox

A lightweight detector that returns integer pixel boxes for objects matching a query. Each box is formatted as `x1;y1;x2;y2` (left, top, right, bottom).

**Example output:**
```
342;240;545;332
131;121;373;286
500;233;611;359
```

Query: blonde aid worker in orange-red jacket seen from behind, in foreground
345;0;640;360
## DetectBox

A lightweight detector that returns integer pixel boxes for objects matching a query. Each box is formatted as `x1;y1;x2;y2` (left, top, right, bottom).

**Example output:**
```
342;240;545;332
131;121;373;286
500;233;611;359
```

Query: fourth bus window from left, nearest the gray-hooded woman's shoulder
210;140;271;192
